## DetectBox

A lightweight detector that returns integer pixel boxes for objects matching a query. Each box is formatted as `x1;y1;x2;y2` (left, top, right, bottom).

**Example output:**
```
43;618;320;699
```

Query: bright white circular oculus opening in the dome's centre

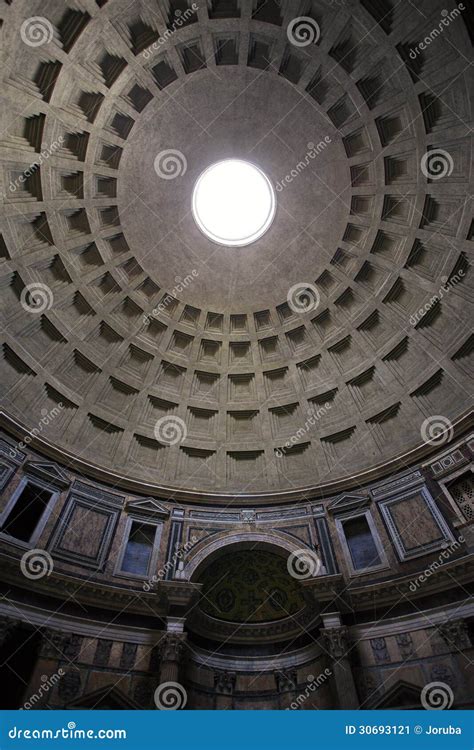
192;159;276;247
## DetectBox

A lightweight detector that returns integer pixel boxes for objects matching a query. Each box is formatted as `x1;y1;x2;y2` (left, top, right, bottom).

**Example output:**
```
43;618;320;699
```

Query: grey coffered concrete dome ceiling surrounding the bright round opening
0;0;473;500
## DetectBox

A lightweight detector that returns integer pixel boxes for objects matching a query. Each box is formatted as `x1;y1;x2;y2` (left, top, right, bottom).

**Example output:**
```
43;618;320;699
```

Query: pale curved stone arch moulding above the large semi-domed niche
180;531;310;581
